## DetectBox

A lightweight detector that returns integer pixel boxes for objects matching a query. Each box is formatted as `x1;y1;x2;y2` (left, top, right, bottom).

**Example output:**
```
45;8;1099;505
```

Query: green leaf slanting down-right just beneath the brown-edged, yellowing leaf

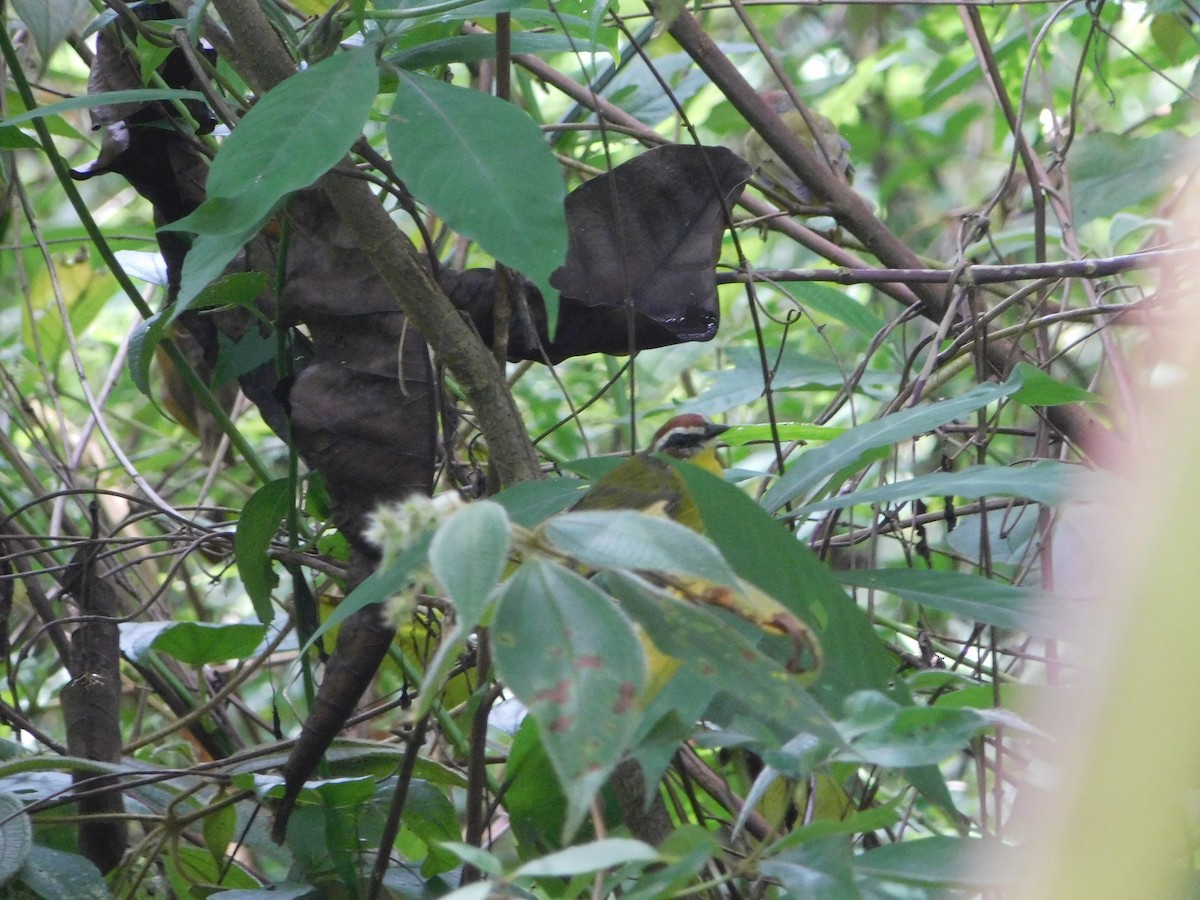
601;571;838;743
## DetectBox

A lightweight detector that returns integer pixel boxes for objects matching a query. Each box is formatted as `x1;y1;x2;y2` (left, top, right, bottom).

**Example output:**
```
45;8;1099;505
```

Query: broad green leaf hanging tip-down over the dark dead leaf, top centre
388;72;566;320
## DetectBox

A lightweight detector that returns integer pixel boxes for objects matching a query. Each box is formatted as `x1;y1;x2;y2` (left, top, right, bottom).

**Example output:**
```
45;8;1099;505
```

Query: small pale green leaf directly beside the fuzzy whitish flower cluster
430;500;509;628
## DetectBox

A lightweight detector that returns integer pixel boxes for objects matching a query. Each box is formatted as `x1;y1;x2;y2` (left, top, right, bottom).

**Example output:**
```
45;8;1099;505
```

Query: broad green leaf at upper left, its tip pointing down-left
163;49;379;234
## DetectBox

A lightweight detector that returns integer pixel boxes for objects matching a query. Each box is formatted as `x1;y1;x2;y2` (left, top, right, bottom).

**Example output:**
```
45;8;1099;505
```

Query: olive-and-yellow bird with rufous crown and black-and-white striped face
574;413;728;532
